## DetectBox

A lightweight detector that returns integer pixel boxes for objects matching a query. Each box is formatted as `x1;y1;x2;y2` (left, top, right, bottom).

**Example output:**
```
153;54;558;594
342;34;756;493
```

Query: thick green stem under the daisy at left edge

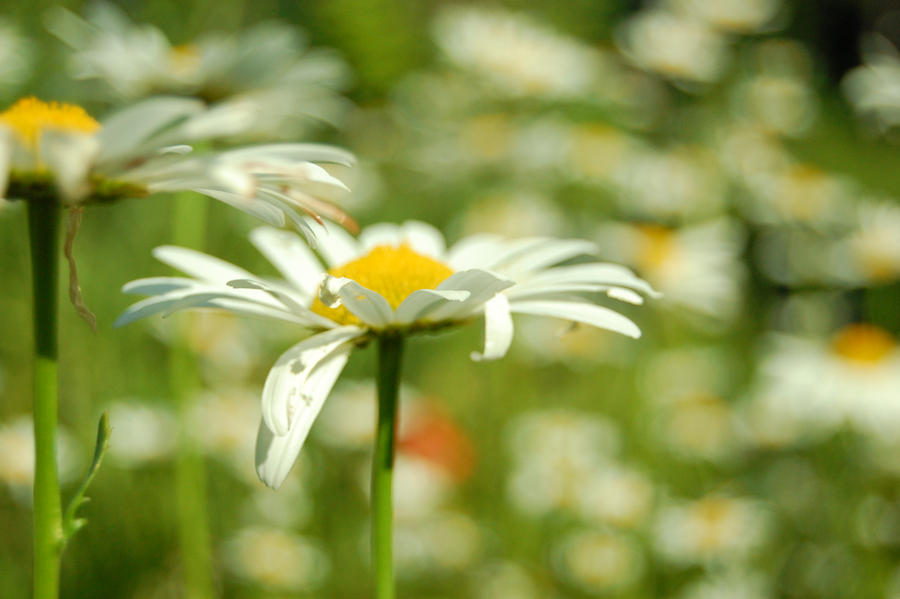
27;200;62;599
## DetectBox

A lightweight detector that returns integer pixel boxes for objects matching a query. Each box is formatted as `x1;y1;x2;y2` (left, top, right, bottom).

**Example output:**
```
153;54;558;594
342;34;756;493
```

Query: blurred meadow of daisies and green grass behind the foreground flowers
0;0;900;599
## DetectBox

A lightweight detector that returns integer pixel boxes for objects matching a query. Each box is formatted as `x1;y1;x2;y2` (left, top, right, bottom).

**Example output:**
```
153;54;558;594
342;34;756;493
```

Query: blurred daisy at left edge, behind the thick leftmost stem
0;415;81;501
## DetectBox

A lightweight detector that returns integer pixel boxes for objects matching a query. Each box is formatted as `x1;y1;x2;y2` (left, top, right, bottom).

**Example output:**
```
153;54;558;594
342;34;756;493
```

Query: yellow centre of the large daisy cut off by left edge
0;97;100;149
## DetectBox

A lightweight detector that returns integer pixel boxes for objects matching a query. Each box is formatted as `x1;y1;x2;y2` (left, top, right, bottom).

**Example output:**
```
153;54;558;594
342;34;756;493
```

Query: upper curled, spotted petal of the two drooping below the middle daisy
262;327;363;437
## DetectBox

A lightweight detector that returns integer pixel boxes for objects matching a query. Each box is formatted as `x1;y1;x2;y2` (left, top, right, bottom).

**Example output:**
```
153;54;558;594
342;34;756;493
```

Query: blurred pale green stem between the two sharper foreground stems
169;193;214;599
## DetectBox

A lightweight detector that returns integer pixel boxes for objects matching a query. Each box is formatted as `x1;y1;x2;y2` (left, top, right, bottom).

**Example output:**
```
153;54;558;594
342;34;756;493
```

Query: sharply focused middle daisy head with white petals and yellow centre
118;222;656;487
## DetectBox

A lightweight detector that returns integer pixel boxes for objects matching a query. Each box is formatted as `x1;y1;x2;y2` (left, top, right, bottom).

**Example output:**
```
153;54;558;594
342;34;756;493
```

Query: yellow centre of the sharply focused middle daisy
310;245;453;324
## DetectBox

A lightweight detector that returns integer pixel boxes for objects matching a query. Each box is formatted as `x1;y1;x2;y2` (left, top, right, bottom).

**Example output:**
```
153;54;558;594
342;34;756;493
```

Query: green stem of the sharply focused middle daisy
372;336;403;599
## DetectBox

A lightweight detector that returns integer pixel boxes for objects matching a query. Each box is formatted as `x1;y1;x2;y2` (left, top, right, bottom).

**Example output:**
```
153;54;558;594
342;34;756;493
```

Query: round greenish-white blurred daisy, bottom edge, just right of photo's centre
553;530;644;595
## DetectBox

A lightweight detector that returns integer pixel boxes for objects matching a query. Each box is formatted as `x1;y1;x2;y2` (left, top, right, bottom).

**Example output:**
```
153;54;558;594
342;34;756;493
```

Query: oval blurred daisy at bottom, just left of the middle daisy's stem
223;528;331;593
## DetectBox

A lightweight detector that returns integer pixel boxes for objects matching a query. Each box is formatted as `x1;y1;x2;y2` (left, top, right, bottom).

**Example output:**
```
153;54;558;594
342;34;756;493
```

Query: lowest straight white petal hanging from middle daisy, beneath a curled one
256;345;352;489
